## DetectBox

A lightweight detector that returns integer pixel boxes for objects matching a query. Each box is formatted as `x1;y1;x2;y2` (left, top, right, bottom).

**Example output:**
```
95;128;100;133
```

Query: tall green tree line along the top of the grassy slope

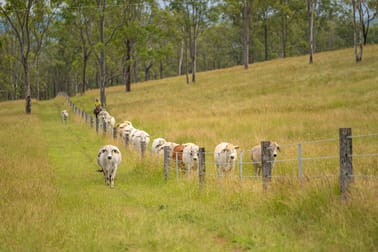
0;0;378;113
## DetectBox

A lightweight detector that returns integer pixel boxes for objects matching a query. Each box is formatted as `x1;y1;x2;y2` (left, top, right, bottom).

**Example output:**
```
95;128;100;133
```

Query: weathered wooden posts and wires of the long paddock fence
58;93;378;195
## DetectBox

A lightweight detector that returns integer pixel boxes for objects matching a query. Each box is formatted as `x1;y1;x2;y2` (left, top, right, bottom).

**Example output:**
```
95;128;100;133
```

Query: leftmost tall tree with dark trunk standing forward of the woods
0;0;54;114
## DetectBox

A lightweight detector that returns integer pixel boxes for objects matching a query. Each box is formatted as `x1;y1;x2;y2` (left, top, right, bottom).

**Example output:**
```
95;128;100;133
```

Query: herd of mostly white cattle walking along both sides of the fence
61;110;280;187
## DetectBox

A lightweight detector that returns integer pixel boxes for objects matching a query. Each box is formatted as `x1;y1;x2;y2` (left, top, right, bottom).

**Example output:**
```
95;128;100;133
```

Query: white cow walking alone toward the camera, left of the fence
97;145;122;187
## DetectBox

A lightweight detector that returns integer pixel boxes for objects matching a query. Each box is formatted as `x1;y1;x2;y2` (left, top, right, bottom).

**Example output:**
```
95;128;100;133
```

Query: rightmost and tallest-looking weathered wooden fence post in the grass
339;128;353;199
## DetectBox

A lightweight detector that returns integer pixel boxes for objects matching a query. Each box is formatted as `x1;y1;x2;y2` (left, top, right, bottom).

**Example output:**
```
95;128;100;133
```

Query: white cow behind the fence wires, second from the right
214;142;239;173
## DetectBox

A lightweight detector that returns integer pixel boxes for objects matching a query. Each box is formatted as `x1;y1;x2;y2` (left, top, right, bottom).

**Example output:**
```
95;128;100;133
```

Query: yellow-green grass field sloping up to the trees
0;46;378;251
